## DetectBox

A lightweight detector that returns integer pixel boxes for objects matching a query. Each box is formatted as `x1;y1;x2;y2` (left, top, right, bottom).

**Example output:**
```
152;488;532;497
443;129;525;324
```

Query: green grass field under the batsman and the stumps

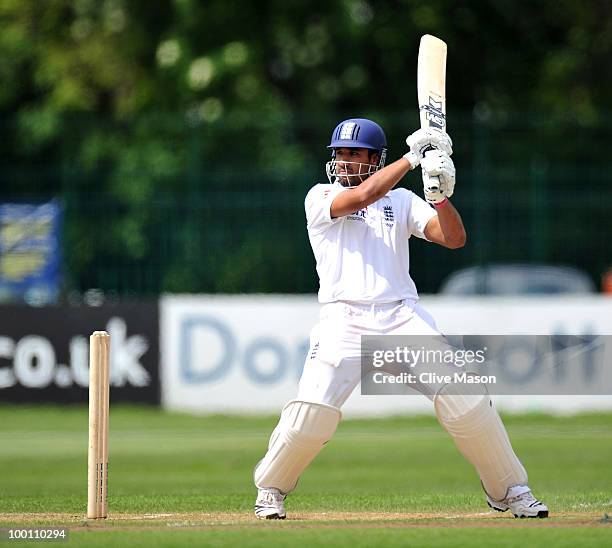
0;406;612;546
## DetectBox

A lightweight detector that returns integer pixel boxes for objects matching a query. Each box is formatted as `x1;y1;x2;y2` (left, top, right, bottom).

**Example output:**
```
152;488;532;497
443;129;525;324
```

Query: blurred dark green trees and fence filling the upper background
0;0;612;296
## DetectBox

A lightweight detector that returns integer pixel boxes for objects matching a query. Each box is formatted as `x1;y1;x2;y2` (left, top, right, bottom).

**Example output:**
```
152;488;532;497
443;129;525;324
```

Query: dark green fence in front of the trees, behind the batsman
0;112;612;297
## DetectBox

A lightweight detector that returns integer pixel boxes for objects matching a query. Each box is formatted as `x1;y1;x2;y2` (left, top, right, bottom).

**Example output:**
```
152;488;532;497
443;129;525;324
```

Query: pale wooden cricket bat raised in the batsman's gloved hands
417;34;447;192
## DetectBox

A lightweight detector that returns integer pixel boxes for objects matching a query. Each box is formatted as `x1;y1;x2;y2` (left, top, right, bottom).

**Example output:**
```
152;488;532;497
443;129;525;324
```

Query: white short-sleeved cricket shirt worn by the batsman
304;183;436;303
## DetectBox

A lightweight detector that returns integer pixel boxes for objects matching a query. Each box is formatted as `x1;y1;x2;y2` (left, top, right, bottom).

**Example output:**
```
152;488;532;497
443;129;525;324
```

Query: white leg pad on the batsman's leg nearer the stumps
254;400;342;494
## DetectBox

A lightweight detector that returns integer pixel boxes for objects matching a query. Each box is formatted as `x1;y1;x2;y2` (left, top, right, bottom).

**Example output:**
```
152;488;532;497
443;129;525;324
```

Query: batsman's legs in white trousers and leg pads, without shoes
254;301;528;501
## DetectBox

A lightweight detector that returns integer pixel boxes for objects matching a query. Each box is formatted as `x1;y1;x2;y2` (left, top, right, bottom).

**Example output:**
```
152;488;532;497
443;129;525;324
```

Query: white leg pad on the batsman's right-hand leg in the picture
434;385;527;501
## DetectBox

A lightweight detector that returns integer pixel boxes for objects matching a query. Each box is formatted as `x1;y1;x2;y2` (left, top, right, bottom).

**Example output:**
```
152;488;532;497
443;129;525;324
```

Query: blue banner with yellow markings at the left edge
0;201;62;305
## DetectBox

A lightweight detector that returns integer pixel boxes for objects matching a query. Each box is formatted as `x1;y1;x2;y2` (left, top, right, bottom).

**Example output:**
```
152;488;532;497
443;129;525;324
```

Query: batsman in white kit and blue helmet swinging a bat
254;118;548;519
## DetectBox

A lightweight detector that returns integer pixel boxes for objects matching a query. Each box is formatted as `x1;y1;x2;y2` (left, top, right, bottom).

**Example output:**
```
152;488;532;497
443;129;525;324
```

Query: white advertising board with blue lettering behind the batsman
160;295;612;416
